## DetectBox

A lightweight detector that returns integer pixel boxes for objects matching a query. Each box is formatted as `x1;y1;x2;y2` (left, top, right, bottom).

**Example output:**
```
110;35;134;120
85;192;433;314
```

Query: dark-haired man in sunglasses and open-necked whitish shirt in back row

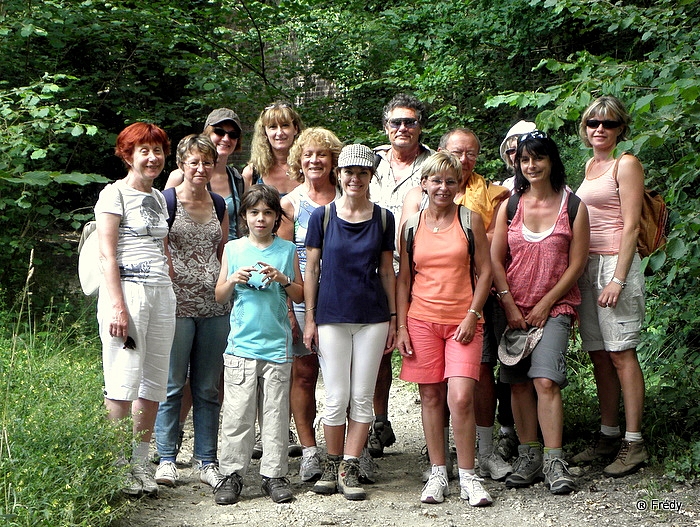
368;93;435;457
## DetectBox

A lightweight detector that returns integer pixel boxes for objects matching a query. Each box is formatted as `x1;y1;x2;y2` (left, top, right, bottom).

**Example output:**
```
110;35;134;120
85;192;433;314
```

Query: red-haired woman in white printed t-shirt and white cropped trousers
95;122;175;496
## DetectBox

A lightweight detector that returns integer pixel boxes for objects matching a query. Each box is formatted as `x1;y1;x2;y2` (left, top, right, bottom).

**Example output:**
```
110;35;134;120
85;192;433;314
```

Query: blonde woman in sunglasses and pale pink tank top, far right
573;96;649;477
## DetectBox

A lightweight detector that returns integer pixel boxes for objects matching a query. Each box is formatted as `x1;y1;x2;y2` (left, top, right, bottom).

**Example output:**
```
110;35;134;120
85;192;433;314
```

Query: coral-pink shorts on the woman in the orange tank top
399;317;484;384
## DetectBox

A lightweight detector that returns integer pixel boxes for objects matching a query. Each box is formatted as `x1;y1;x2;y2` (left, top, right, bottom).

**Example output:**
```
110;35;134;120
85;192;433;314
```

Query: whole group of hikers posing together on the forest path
95;94;648;506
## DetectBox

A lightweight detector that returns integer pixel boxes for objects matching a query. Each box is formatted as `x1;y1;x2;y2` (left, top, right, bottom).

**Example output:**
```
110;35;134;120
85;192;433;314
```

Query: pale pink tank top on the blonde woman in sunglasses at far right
576;165;623;254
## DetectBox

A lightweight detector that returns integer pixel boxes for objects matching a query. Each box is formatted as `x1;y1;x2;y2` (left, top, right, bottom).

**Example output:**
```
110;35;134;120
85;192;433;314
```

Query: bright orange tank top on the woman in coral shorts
408;211;483;324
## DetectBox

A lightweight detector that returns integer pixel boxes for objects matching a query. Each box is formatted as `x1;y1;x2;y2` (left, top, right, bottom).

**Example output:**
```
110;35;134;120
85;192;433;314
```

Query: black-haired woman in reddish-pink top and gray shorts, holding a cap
491;130;589;494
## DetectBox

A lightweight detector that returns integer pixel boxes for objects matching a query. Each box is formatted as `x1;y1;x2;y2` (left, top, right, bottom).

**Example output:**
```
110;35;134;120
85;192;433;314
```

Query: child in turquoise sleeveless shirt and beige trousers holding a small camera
214;185;304;505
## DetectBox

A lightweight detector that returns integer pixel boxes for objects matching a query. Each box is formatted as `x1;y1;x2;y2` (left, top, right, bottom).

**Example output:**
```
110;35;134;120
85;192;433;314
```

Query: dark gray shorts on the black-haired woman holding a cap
500;315;571;388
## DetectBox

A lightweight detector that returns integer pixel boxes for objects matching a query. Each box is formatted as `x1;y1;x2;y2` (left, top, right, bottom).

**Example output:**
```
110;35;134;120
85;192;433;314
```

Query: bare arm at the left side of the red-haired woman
96;212;129;339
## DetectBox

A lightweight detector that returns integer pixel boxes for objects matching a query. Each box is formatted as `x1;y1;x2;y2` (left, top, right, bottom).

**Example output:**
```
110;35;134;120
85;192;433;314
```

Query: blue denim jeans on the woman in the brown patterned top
155;315;229;462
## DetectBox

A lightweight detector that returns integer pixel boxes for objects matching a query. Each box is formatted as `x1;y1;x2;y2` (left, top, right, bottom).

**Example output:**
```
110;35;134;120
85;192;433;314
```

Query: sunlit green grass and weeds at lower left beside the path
0;304;123;527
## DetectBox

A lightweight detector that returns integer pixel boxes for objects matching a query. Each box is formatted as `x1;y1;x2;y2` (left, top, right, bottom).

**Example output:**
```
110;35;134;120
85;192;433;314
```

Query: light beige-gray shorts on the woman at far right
578;254;644;351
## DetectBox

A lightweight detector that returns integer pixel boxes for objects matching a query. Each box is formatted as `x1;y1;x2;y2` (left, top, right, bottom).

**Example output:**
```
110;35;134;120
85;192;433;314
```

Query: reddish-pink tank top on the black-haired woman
506;192;581;317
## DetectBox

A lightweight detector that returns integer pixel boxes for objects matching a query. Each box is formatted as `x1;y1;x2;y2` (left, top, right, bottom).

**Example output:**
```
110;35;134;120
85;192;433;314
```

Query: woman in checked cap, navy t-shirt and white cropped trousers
304;145;396;500
